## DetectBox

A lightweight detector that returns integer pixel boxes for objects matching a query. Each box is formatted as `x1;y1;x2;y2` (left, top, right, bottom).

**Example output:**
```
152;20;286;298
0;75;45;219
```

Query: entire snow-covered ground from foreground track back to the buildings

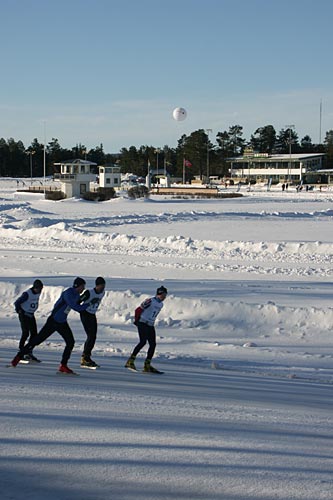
0;179;333;500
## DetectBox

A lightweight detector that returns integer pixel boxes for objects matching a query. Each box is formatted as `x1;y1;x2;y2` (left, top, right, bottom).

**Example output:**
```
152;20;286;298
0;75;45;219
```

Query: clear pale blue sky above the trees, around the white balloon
0;0;333;152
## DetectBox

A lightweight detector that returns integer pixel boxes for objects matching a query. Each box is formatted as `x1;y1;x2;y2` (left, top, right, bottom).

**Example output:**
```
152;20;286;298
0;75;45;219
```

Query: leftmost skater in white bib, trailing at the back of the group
14;279;44;363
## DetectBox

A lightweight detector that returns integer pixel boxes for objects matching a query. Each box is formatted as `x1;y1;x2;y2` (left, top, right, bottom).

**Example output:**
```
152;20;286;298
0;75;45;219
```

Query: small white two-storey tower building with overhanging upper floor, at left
54;160;97;198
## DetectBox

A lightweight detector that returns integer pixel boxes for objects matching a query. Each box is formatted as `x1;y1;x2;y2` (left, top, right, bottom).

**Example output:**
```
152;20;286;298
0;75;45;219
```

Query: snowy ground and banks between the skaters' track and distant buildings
0;182;333;378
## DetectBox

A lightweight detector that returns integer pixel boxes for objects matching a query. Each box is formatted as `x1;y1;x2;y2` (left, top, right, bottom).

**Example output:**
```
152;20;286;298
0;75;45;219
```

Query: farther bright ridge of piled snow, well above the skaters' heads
0;223;333;264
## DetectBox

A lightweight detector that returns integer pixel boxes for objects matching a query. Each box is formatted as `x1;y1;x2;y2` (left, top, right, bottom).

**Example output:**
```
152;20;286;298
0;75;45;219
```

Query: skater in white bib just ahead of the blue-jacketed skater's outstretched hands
80;276;105;368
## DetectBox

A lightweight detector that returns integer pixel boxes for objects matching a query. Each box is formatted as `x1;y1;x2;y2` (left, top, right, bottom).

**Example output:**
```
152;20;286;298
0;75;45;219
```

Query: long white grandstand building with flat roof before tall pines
227;153;325;181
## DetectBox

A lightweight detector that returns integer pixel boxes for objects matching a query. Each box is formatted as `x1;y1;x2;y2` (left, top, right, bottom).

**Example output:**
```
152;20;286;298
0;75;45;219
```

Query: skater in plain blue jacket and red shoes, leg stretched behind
11;277;88;375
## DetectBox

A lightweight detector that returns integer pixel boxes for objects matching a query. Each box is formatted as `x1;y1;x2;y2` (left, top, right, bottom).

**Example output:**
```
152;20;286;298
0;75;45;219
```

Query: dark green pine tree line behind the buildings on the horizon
0;125;333;178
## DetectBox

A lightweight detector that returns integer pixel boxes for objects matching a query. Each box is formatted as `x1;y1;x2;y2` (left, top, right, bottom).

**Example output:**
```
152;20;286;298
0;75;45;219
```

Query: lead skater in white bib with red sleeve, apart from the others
125;286;168;373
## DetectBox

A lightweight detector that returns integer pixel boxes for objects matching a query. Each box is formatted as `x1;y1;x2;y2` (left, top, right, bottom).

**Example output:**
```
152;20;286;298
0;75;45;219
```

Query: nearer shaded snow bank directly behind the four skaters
0;281;333;359
